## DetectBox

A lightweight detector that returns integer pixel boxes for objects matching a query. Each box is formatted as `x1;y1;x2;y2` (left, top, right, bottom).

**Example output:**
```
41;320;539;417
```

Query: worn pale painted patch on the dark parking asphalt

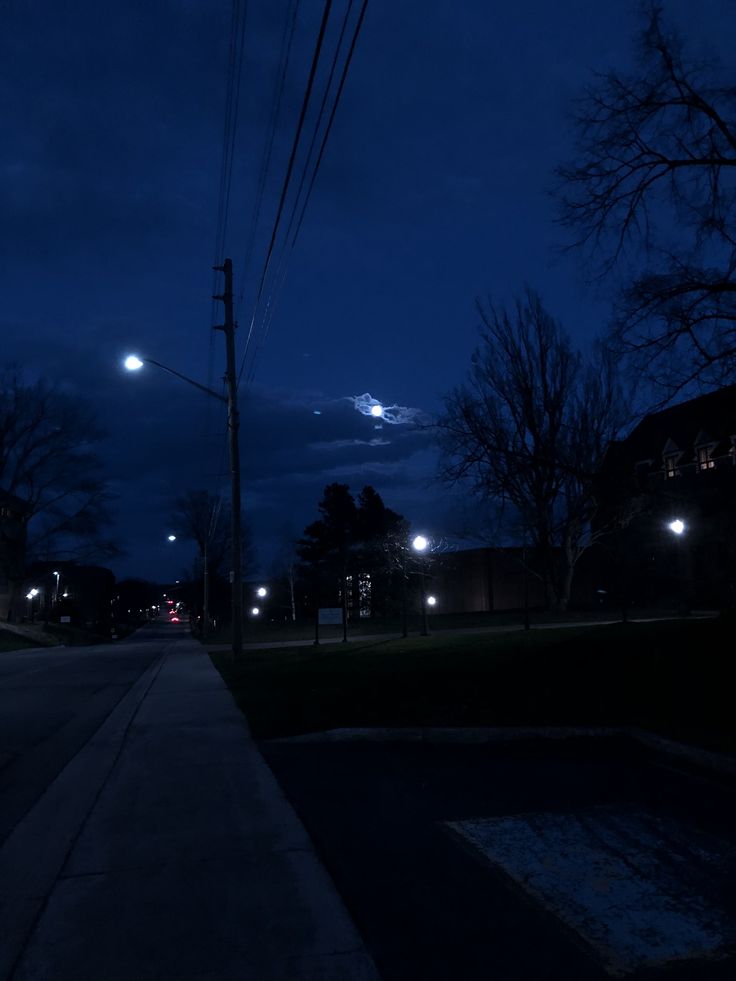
447;807;736;975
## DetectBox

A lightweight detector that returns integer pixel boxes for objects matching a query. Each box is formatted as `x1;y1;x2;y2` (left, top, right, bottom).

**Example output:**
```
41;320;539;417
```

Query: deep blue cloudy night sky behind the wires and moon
0;0;736;581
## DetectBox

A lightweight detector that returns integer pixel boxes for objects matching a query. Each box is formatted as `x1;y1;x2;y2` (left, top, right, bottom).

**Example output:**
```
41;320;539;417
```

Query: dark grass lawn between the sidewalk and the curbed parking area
211;619;736;752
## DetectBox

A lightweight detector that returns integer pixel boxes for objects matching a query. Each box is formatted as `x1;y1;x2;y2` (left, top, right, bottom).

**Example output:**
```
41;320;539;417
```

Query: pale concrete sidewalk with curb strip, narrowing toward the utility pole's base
0;639;378;981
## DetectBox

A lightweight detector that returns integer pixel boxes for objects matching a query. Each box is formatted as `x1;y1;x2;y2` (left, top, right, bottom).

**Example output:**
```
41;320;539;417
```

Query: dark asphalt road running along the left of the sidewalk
0;624;172;844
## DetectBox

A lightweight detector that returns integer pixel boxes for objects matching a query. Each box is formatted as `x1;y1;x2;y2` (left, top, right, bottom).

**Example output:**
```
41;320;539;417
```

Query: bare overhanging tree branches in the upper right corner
558;2;736;399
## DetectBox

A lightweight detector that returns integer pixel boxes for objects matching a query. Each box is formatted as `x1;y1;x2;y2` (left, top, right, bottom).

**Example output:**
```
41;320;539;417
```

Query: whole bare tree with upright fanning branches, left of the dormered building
437;290;625;609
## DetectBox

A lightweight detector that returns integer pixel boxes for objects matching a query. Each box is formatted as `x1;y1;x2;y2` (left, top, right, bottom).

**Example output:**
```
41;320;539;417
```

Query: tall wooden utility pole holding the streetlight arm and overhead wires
214;259;243;657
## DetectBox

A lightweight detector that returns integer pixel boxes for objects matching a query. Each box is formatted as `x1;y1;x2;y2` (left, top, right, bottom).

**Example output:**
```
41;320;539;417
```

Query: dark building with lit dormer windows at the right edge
597;385;736;608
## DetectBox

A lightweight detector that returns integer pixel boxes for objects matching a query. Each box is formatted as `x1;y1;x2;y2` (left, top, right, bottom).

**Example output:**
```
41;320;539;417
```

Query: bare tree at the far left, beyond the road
0;368;118;572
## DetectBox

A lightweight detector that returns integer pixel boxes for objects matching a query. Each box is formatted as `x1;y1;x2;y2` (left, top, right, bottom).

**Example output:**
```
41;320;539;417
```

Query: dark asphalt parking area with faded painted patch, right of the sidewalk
261;739;736;981
